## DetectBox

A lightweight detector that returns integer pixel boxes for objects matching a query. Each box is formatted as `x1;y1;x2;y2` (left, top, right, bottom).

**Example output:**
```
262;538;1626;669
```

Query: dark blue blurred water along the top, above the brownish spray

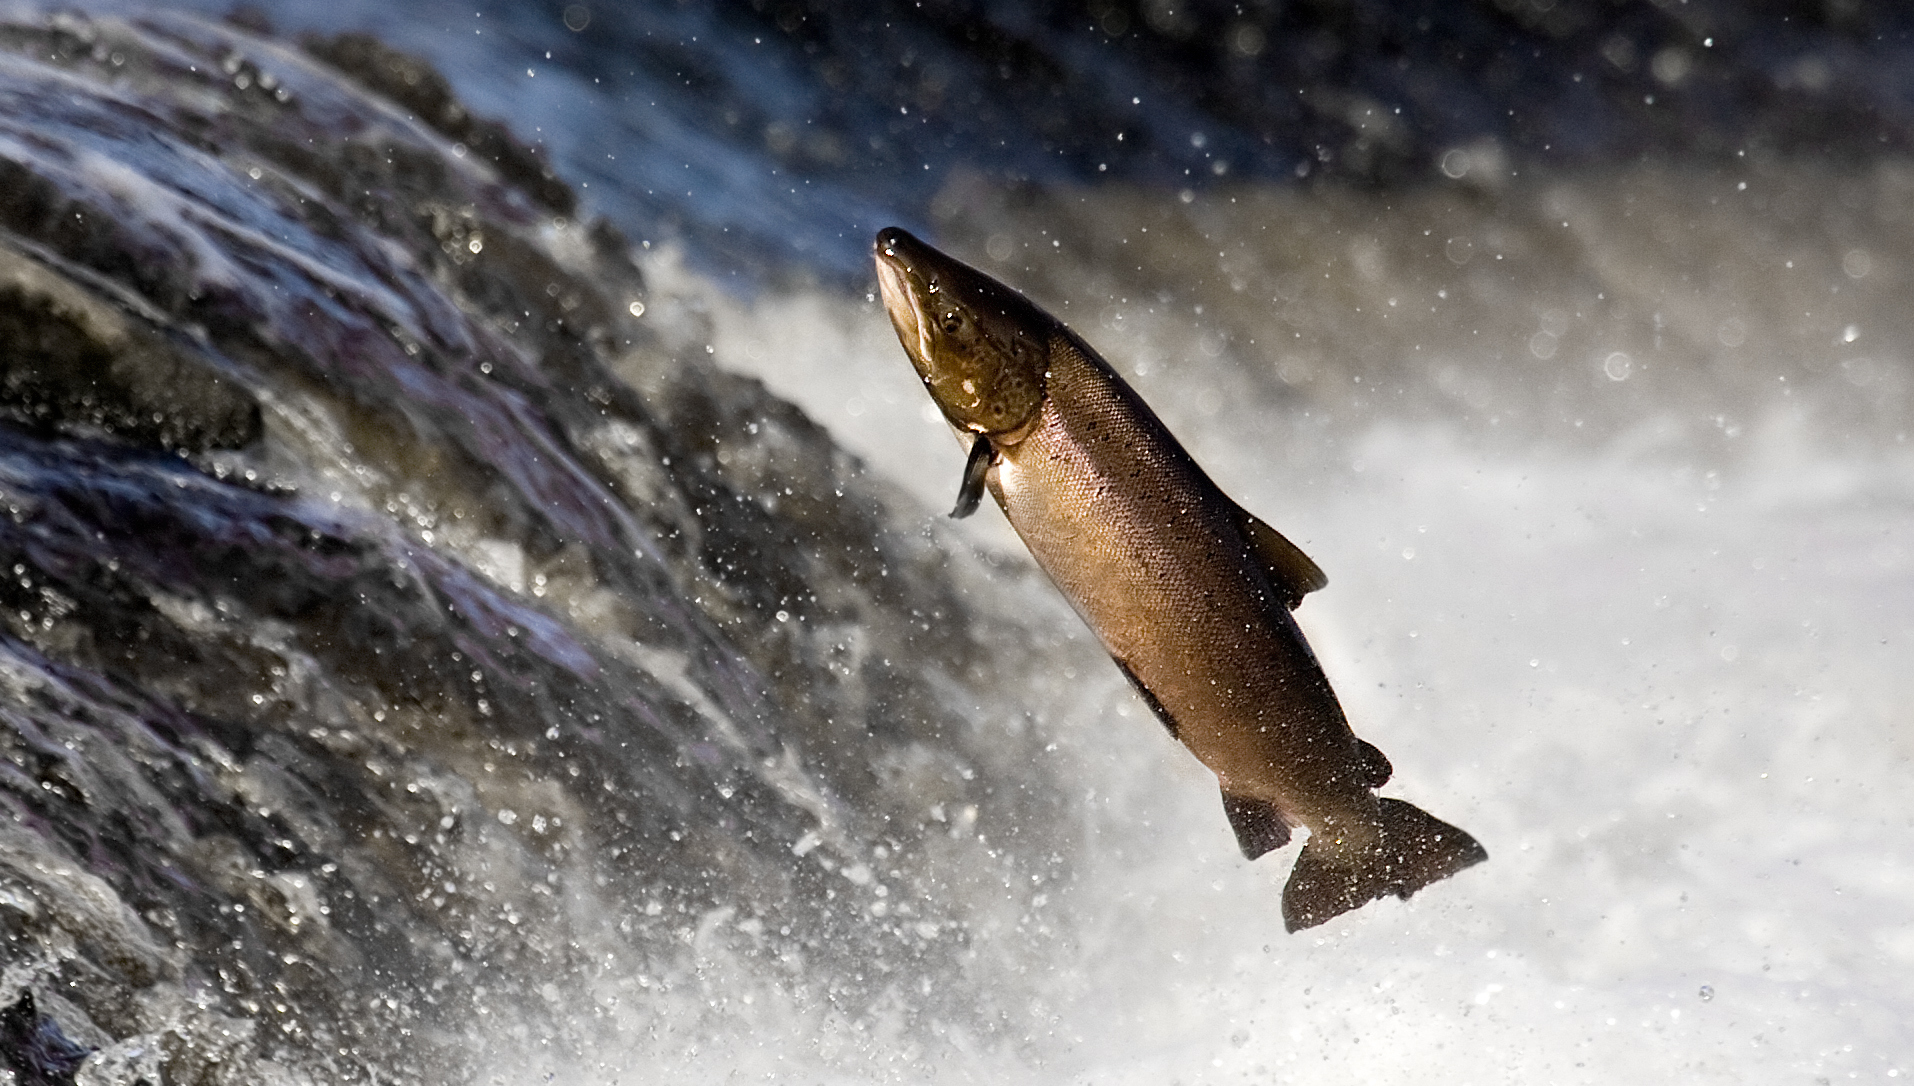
93;0;1914;282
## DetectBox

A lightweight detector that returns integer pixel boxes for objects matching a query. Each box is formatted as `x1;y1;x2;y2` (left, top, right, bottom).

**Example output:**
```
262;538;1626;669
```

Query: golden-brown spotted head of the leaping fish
875;226;1060;442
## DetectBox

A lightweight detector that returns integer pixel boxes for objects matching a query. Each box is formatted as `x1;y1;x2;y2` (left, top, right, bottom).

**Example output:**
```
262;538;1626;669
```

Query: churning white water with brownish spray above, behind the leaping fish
532;169;1914;1084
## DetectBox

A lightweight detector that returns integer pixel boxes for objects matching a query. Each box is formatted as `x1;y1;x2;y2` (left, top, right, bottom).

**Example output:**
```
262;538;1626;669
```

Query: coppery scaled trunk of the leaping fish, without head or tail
988;337;1376;837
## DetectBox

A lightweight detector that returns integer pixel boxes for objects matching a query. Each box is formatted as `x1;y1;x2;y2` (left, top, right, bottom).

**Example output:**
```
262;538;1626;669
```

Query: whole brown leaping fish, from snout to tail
877;230;1487;931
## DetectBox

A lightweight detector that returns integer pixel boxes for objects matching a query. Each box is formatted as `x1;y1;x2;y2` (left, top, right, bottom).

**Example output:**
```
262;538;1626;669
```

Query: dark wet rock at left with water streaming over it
0;6;1068;1082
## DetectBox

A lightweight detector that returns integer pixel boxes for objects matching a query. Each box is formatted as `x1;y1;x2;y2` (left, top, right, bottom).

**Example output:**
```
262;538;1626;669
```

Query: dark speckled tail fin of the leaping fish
1282;799;1489;931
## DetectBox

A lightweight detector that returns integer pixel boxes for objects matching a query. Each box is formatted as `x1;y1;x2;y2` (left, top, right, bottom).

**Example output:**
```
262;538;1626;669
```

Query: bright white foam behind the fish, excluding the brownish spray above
616;176;1914;1084
